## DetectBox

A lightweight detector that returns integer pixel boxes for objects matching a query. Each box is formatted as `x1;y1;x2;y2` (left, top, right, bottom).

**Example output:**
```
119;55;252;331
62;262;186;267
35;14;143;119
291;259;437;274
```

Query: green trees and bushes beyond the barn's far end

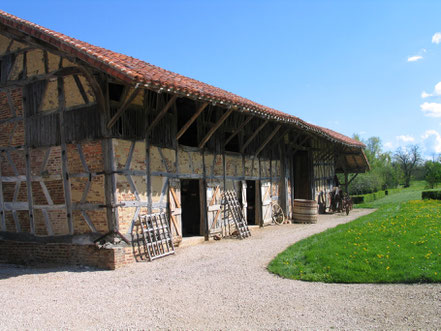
349;135;441;195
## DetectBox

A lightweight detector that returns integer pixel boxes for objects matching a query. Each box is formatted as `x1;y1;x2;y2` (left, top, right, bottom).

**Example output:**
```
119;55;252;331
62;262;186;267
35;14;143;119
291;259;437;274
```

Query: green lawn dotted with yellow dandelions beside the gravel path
268;184;441;283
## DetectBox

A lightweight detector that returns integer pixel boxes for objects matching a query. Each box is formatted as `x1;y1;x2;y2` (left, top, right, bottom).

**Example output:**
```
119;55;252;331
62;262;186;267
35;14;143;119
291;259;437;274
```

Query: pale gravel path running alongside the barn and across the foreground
0;210;441;330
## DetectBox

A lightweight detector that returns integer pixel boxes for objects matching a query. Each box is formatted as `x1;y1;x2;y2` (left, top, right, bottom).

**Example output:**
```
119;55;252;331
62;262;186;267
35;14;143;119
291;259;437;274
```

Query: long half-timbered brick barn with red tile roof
0;11;368;268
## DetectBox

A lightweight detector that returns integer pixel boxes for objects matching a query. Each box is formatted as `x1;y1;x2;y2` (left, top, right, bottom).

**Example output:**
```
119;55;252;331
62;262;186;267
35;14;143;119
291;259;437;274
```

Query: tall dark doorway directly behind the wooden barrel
293;151;312;199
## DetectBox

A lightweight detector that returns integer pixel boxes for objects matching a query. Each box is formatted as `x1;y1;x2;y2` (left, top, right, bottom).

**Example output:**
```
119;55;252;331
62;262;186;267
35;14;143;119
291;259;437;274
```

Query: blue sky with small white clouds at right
1;0;441;157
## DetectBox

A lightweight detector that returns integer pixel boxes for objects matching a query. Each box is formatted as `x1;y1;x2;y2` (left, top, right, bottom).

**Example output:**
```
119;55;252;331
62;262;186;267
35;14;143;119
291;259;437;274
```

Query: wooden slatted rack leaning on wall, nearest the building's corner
139;213;175;261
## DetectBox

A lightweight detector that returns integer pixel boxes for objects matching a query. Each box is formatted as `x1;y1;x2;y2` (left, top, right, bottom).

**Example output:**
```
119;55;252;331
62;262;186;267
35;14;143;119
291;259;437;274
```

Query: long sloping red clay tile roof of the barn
0;10;365;148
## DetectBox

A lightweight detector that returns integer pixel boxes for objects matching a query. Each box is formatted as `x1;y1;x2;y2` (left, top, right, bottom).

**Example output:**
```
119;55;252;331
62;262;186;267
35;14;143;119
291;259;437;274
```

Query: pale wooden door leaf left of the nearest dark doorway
168;178;182;242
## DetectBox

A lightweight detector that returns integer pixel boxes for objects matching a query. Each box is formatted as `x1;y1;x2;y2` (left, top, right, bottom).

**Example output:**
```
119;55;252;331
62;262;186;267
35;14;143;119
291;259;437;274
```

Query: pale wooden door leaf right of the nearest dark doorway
207;182;223;235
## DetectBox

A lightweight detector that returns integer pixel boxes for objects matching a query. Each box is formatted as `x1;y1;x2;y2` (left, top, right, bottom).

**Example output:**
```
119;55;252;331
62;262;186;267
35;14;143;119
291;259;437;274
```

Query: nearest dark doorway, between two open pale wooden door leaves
181;179;202;237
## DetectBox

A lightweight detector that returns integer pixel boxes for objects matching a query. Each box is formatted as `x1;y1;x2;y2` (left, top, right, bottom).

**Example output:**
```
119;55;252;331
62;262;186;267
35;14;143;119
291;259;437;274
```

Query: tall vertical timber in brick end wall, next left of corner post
58;77;74;234
